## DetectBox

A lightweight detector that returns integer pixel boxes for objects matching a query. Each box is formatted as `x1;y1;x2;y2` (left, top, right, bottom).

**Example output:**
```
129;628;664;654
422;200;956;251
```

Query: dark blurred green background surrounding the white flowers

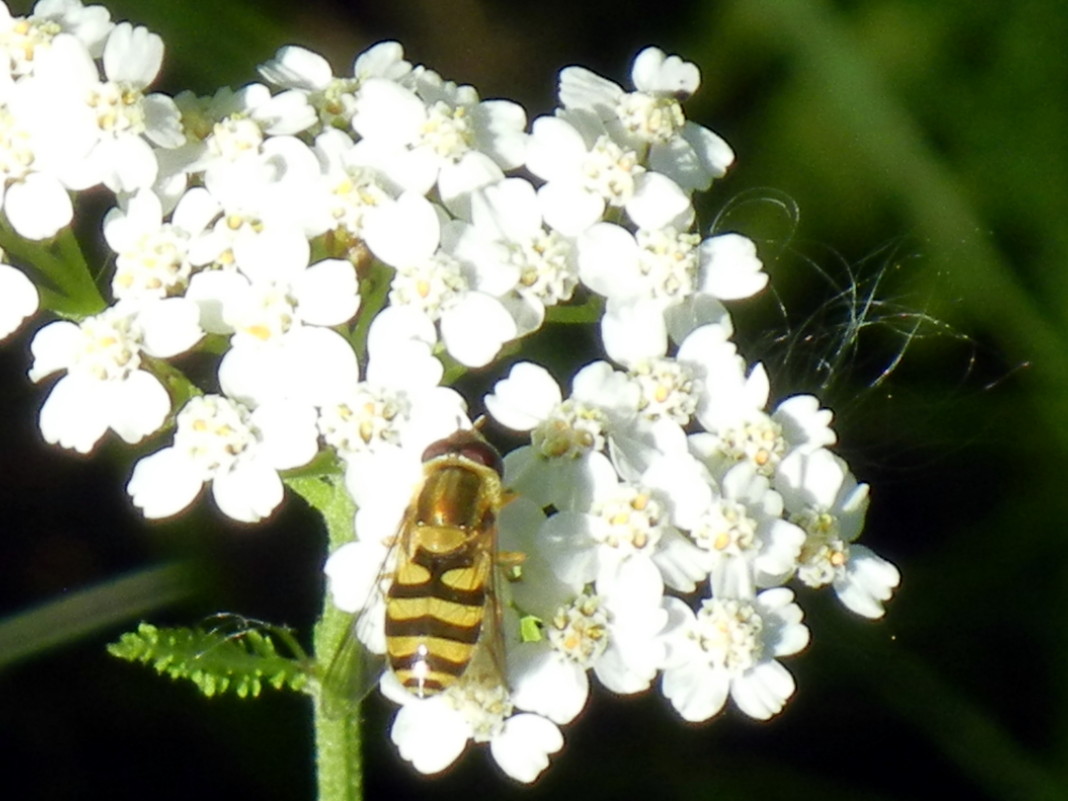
0;0;1068;801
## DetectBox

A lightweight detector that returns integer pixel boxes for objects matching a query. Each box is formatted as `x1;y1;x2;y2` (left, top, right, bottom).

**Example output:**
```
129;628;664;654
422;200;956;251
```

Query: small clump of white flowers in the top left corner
0;0;177;239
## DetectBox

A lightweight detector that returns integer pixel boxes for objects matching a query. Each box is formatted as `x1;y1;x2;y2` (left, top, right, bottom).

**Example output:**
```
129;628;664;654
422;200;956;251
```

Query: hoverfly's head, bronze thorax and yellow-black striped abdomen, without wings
386;430;502;697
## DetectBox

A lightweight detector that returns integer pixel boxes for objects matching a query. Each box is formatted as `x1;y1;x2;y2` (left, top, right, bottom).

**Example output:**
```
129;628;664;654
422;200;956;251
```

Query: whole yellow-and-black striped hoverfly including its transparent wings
324;429;506;712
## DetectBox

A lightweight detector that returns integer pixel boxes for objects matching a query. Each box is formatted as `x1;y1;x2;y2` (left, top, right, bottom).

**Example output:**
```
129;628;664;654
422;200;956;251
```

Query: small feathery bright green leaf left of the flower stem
108;623;309;698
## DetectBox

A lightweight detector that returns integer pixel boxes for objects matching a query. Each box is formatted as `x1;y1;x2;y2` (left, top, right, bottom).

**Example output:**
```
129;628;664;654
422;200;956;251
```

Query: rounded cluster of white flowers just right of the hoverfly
486;356;899;723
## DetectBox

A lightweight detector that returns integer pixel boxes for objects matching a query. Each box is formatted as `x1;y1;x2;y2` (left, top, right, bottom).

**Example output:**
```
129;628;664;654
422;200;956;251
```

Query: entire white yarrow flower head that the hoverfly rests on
0;0;898;782
